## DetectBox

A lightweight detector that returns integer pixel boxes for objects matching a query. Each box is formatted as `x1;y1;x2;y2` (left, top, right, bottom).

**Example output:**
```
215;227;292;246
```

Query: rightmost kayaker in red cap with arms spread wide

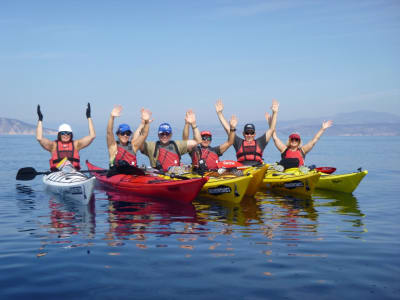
272;120;333;169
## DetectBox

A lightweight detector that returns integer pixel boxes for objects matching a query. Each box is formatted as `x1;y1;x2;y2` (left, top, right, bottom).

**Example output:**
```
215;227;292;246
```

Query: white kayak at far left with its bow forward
43;171;96;204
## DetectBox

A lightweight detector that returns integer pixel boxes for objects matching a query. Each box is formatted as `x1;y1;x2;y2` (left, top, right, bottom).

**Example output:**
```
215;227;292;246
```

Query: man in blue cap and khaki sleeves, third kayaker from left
140;112;201;172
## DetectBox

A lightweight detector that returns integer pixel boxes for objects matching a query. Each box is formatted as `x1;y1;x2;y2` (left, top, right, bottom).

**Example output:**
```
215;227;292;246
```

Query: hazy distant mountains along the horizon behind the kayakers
0;110;400;137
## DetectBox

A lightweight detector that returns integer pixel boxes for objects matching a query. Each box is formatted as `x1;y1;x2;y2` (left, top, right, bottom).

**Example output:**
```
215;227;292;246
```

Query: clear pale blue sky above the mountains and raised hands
0;0;400;130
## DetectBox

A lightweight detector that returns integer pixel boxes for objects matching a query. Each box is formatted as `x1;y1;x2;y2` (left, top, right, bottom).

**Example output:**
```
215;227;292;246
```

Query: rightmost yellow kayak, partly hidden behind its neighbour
317;170;368;193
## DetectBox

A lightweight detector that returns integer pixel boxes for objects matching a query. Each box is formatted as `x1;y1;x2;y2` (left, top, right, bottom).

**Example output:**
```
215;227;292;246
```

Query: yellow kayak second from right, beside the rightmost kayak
262;168;321;196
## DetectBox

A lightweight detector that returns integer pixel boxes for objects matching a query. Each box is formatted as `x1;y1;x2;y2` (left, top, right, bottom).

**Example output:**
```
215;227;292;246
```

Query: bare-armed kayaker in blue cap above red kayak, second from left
107;105;151;176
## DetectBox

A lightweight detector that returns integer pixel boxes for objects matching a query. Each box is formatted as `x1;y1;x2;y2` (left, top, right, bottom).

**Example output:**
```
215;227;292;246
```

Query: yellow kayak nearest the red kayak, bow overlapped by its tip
189;174;253;203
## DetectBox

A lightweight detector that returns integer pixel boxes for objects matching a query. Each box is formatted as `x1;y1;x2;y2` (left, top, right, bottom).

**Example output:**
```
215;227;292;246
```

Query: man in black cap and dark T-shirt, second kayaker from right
215;99;279;166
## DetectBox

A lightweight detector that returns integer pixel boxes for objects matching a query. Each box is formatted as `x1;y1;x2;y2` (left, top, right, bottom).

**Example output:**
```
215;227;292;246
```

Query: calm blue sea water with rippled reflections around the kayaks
0;136;400;299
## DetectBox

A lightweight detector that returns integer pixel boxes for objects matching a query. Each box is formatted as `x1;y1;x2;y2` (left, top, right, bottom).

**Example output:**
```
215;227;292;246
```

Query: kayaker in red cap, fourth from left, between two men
182;110;237;172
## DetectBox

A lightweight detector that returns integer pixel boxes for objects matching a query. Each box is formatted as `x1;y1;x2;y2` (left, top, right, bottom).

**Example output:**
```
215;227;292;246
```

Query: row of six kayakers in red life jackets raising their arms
36;99;332;176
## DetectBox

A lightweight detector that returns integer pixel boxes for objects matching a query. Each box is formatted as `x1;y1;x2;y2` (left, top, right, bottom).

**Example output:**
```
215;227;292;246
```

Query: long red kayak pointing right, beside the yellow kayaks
86;161;208;203
